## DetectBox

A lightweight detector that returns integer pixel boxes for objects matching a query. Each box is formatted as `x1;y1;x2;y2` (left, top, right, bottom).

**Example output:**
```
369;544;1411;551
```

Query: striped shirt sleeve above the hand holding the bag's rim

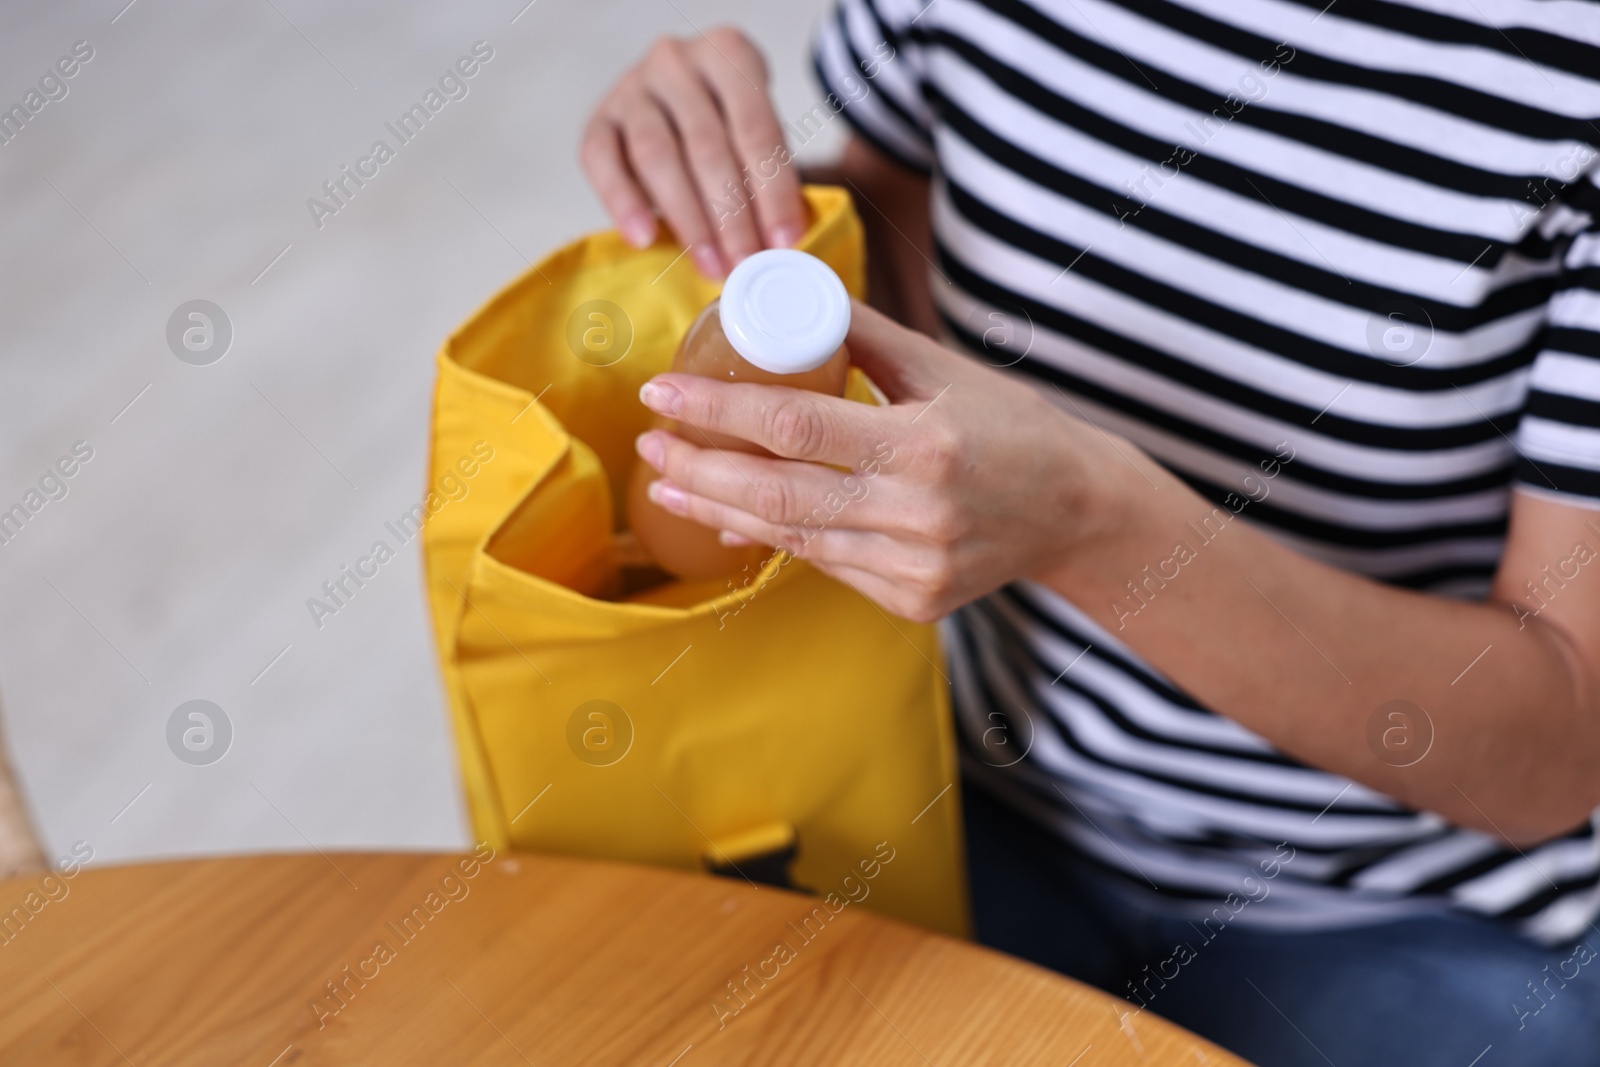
812;0;933;174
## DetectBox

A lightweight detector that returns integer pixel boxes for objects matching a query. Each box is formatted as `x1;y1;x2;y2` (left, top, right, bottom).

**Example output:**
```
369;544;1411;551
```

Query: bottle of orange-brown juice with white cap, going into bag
627;248;850;579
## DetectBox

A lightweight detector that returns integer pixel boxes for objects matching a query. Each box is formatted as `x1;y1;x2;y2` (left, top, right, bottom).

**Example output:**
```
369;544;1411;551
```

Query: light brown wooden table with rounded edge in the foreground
0;854;1243;1067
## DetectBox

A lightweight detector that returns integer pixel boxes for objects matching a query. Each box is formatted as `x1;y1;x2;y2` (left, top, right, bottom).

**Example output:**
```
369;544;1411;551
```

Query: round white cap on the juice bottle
720;248;850;374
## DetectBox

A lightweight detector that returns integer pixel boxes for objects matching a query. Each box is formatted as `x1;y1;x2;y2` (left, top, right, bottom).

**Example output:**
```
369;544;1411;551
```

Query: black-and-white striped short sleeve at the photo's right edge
1517;158;1600;507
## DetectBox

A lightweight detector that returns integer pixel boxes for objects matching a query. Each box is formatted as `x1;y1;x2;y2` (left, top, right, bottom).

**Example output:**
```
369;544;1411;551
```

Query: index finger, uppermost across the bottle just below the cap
638;374;906;467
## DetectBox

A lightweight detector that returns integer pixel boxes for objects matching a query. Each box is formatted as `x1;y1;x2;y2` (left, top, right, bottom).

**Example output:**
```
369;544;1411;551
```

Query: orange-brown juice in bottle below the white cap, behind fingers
627;301;850;579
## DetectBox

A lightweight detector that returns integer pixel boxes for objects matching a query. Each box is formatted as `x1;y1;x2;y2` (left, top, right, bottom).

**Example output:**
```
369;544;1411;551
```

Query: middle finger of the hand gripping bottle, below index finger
637;430;894;530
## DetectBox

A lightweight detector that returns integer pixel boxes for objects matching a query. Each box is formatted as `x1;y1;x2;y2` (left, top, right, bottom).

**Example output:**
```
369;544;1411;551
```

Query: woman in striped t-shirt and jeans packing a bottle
582;0;1600;1067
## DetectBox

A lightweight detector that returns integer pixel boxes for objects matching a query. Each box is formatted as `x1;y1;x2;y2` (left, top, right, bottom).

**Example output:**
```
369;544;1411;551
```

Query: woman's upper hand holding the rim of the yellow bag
579;27;805;278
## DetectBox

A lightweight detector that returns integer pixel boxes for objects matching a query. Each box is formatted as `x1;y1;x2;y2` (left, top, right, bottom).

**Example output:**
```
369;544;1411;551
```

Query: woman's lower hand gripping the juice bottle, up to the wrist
637;302;1149;622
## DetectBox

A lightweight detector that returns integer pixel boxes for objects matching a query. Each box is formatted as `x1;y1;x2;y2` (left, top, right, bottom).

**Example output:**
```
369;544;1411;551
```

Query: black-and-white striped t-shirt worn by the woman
816;0;1600;942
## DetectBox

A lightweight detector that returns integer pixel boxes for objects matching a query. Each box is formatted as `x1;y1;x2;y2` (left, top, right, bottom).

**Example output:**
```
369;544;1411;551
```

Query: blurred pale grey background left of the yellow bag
0;0;842;862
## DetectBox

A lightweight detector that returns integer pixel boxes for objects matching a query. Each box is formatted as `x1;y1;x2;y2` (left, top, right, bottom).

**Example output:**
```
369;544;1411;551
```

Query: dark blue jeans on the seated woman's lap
963;785;1600;1067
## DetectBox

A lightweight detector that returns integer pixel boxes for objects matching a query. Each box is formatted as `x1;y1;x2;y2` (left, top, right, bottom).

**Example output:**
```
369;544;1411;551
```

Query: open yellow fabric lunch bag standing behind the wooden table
413;186;966;934
